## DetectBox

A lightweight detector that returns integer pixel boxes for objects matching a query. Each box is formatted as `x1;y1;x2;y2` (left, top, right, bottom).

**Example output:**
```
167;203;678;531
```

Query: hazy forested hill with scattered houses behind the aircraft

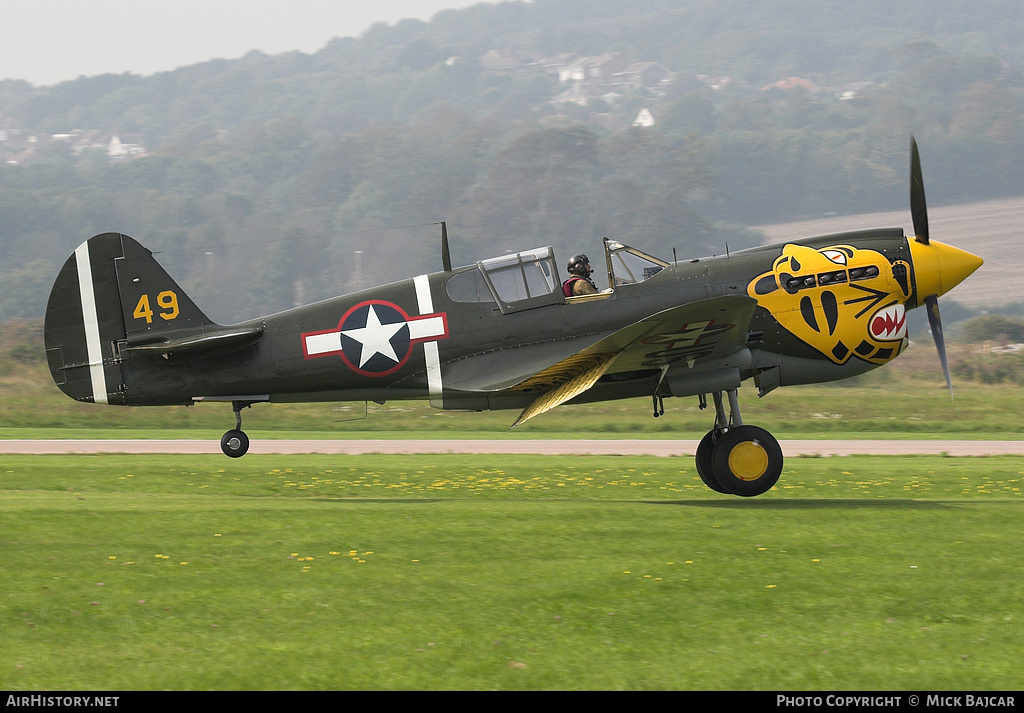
0;0;1024;321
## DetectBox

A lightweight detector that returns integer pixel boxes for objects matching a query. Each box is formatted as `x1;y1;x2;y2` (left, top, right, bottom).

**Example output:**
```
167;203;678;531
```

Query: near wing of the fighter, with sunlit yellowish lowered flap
509;295;757;426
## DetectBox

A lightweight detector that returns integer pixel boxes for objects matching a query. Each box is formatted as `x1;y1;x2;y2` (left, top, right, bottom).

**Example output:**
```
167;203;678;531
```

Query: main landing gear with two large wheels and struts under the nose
695;389;782;497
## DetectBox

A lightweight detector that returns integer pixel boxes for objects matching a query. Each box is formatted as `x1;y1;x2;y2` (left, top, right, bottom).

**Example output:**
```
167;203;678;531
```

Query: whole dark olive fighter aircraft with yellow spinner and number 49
45;139;982;496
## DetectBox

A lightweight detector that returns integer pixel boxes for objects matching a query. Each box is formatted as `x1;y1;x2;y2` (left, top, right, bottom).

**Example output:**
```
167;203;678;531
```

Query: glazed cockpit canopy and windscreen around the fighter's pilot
445;238;670;314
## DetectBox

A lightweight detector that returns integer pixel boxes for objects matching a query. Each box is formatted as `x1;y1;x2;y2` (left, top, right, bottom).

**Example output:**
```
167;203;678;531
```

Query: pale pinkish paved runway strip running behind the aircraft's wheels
0;438;1024;456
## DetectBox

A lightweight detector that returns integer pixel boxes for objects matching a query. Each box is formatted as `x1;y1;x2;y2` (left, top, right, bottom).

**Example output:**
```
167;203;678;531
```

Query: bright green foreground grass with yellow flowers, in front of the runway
0;455;1024;690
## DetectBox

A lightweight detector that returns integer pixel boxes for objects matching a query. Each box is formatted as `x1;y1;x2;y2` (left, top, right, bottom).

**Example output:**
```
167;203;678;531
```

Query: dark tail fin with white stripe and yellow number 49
44;233;213;404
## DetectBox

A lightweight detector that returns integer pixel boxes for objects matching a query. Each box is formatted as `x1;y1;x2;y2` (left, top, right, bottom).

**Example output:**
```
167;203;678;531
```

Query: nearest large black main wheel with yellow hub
712;425;782;498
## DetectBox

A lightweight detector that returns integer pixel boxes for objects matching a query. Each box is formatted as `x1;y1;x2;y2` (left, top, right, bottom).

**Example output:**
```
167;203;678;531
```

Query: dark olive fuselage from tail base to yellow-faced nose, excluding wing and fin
110;228;950;409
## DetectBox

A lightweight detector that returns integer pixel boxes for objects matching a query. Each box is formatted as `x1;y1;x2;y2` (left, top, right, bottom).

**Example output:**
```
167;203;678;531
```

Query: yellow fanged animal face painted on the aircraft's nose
746;245;911;365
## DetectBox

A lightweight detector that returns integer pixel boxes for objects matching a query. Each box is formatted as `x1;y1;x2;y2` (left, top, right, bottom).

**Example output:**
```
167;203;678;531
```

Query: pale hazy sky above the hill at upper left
0;0;503;85
